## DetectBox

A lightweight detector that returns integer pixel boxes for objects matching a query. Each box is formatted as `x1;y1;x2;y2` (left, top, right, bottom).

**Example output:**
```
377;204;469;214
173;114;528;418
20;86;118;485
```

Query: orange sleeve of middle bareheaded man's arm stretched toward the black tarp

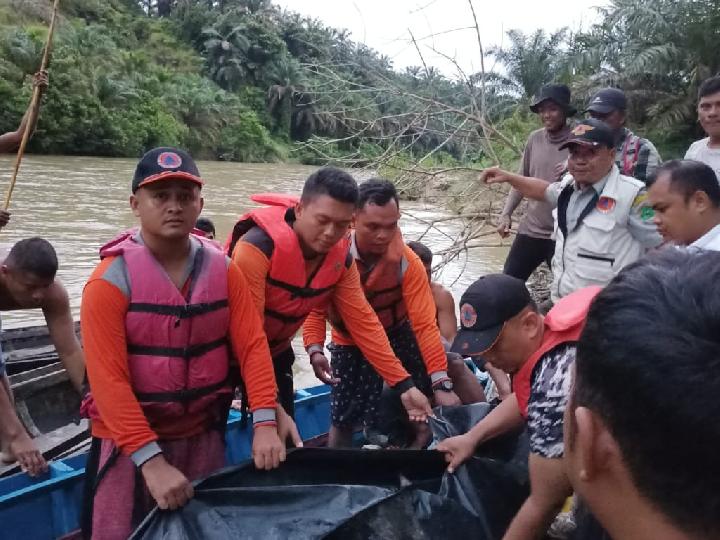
333;261;410;386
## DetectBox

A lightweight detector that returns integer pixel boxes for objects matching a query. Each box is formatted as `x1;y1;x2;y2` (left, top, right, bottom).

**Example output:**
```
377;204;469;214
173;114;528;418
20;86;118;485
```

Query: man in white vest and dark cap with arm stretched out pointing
481;118;662;302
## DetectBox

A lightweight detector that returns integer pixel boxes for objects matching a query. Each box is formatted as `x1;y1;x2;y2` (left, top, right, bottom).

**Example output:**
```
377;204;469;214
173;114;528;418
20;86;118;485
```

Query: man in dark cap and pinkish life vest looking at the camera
80;148;299;539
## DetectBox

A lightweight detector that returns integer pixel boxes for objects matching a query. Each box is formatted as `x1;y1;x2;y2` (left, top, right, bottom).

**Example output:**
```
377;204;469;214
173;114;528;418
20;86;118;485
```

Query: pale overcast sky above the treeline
274;0;607;75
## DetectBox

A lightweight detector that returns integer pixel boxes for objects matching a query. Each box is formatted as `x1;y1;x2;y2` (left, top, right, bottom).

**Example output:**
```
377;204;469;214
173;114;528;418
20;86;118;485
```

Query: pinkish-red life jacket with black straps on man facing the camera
82;231;232;427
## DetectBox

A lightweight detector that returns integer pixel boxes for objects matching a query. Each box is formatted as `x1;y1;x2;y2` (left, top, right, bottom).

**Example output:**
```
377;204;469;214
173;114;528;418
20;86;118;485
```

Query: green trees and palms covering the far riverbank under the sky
0;0;720;167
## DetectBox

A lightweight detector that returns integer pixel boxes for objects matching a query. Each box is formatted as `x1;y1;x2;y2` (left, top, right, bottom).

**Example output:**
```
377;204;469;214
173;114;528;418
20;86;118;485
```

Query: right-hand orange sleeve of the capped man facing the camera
228;262;277;411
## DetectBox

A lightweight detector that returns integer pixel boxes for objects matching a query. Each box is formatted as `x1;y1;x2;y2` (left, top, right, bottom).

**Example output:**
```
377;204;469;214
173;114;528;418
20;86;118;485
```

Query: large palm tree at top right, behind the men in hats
571;0;720;130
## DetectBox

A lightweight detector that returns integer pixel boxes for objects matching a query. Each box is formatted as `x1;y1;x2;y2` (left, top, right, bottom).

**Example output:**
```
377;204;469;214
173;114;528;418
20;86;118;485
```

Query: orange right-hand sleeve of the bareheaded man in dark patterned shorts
402;247;447;378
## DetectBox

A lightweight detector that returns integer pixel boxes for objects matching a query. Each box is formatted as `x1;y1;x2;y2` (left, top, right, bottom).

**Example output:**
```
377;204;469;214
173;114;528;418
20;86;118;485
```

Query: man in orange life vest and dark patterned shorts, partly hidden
303;179;460;446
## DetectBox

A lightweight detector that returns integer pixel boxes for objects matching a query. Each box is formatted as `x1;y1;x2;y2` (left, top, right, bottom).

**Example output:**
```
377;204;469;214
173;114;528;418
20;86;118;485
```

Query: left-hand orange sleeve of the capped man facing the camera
80;258;158;455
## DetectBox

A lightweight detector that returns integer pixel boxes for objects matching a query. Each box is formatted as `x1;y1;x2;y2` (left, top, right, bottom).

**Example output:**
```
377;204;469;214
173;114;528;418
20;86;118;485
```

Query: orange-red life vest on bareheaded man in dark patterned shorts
328;230;408;334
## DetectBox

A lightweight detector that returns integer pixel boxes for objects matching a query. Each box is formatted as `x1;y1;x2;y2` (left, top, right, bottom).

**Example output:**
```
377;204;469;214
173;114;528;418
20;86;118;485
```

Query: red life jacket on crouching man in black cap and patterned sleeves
512;287;602;418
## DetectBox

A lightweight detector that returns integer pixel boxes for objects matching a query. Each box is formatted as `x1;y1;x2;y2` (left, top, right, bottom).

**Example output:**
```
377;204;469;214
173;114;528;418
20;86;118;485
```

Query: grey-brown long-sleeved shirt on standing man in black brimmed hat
503;126;572;238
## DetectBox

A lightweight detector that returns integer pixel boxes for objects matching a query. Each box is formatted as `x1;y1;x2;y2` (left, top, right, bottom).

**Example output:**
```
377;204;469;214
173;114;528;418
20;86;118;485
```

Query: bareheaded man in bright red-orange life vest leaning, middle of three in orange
228;167;432;421
